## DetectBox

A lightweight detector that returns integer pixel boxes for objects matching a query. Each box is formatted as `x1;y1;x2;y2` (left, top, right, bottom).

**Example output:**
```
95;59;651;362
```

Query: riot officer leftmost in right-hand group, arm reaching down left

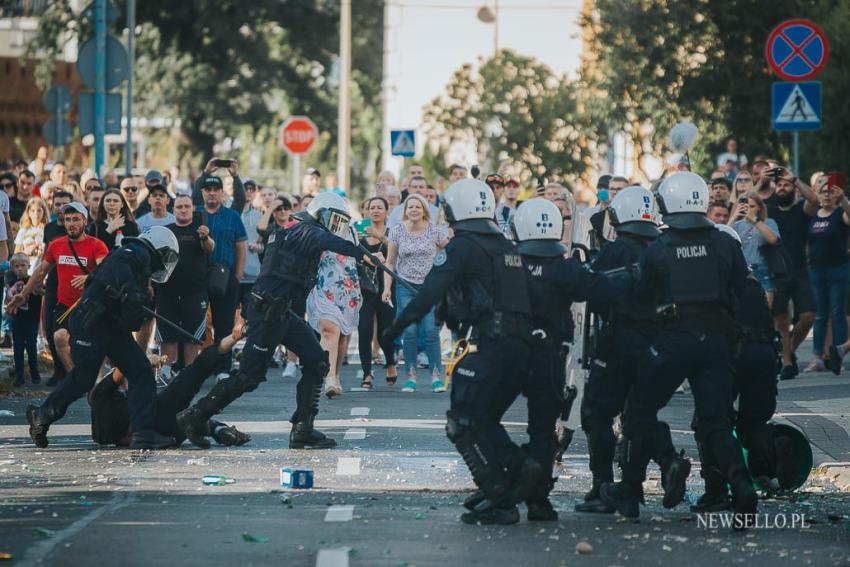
385;179;540;524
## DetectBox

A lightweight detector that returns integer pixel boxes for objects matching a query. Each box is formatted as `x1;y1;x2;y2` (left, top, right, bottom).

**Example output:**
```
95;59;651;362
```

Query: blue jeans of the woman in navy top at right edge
809;264;850;356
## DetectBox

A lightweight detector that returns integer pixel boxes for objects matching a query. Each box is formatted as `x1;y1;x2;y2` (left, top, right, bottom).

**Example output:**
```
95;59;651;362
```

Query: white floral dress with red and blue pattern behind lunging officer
307;252;363;335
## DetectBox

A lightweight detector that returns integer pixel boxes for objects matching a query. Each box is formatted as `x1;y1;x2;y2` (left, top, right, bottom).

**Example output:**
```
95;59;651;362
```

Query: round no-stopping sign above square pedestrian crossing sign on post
764;18;829;175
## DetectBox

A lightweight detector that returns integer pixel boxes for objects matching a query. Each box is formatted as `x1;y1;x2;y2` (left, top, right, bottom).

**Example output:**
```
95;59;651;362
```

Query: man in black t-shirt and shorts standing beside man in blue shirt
156;195;215;381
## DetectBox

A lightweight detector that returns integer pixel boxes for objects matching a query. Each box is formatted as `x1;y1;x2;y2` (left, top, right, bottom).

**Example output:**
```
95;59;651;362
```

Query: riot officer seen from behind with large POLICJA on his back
599;172;758;528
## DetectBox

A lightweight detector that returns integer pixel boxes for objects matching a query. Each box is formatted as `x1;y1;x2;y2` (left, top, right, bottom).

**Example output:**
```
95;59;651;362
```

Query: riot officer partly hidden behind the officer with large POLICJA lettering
575;186;691;513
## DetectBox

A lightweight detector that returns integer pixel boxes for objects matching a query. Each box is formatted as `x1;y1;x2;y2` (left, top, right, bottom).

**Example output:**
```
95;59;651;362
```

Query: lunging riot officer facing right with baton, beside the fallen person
177;192;368;449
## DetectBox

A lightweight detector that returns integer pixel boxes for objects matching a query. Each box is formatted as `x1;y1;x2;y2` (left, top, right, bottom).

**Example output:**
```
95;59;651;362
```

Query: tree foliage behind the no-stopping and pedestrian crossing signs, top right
582;0;850;178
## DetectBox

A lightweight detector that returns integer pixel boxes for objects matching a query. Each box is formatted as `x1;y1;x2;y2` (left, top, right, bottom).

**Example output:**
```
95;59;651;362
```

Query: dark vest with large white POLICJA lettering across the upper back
660;229;725;305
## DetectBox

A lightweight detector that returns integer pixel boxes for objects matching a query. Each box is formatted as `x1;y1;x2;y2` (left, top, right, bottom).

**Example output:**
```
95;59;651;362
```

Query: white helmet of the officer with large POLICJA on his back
655;171;714;229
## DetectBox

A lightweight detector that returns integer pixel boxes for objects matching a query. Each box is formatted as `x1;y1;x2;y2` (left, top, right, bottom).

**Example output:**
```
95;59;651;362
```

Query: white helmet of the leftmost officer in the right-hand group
443;179;502;234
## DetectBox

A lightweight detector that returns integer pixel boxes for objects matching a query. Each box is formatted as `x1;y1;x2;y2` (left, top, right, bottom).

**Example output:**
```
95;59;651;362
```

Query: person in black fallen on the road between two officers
88;328;251;447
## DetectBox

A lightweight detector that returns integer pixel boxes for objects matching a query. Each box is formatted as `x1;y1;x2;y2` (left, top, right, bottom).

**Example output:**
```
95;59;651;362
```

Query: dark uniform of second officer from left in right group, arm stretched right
491;247;622;520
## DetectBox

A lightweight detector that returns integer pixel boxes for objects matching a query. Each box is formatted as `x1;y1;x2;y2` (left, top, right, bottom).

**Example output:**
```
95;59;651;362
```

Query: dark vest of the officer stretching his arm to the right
523;256;574;342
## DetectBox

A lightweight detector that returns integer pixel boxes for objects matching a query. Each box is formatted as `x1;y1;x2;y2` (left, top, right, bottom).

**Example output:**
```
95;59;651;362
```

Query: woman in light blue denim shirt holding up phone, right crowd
732;191;779;304
